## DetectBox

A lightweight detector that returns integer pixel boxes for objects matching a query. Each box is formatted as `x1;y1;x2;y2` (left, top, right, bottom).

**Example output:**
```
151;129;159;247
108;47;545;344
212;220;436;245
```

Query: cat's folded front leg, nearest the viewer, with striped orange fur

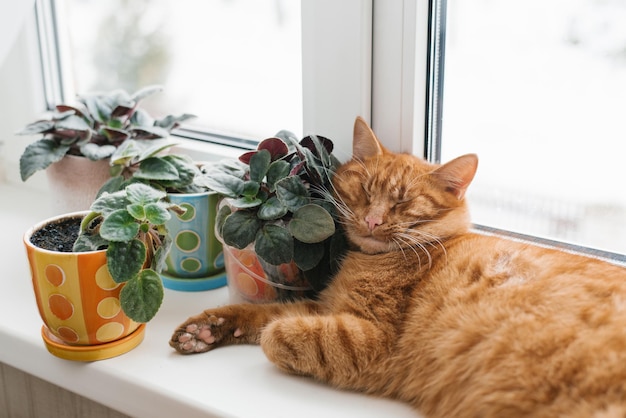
261;314;390;388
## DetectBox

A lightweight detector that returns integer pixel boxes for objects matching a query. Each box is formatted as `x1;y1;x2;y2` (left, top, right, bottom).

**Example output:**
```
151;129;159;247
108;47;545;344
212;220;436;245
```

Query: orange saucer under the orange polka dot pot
41;324;146;361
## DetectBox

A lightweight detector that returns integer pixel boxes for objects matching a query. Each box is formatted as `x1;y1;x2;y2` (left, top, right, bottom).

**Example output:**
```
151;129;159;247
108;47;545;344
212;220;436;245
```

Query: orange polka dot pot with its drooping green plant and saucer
24;184;180;361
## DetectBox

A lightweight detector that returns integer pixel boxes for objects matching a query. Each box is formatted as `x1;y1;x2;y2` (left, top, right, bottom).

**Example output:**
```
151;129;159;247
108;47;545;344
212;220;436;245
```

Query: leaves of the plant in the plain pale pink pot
17;86;194;181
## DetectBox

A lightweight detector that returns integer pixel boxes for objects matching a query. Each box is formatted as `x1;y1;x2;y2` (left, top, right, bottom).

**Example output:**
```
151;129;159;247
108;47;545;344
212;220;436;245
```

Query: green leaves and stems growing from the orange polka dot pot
74;183;184;322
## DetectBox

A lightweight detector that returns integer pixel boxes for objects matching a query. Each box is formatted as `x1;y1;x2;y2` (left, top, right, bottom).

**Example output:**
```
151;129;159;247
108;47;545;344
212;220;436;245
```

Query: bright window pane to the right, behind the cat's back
442;0;626;253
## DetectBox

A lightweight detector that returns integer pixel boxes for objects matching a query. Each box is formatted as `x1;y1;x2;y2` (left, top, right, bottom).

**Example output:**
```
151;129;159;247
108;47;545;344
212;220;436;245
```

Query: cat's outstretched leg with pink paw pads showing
170;301;319;354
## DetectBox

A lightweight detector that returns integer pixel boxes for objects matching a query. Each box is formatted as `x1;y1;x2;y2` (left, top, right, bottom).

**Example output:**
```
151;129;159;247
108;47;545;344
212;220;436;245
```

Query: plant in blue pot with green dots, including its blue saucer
101;140;226;291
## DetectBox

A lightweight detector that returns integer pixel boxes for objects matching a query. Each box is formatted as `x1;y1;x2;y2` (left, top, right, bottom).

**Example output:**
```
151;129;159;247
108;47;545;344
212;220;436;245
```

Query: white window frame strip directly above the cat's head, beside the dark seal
372;0;430;157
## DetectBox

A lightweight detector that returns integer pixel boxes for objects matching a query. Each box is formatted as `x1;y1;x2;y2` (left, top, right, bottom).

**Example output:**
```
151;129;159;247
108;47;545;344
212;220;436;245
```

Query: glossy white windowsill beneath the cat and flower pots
0;183;416;418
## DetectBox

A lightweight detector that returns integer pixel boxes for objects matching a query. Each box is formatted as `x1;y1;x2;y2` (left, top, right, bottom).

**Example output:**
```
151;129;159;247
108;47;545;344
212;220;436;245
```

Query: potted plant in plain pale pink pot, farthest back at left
18;86;193;211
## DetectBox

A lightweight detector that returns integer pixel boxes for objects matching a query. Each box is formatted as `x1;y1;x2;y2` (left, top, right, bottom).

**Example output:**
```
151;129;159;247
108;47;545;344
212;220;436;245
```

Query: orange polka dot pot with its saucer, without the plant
24;212;144;361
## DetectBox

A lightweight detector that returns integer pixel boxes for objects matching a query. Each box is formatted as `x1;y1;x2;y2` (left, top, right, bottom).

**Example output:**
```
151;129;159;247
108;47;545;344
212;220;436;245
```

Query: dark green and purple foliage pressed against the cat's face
196;131;341;287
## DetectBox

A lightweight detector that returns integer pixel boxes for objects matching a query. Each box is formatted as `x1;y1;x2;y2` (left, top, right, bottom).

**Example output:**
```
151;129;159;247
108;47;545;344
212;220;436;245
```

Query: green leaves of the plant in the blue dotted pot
98;139;206;195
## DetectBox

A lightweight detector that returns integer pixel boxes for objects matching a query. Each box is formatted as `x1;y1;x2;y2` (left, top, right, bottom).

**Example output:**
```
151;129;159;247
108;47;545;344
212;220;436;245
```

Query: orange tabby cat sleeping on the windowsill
170;118;626;418
